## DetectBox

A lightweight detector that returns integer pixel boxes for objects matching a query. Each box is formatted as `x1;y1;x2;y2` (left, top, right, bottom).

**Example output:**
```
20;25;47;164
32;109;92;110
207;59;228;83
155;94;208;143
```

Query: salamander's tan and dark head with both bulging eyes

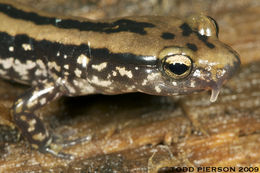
139;15;240;102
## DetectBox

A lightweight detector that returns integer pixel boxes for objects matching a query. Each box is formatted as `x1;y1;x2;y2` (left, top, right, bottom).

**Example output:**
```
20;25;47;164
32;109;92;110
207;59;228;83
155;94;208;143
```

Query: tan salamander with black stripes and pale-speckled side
0;0;240;159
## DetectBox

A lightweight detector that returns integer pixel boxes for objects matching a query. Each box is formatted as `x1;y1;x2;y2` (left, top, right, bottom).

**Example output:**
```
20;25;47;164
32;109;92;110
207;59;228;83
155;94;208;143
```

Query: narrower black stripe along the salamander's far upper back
0;4;155;35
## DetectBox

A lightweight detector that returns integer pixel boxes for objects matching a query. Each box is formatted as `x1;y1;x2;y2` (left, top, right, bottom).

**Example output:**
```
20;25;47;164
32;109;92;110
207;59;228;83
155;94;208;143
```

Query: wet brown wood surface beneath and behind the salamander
0;0;260;172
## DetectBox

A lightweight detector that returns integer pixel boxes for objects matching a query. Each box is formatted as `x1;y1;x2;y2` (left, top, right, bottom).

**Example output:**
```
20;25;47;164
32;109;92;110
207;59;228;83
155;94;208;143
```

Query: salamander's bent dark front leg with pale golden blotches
12;81;70;158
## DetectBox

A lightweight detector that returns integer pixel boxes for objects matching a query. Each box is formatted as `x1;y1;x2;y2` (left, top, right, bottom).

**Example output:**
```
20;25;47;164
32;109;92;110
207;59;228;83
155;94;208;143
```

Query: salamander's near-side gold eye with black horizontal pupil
162;54;192;79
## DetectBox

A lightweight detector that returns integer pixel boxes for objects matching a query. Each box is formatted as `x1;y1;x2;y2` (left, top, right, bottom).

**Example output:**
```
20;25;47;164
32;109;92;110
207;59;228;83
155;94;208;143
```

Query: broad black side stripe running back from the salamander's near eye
0;32;156;66
